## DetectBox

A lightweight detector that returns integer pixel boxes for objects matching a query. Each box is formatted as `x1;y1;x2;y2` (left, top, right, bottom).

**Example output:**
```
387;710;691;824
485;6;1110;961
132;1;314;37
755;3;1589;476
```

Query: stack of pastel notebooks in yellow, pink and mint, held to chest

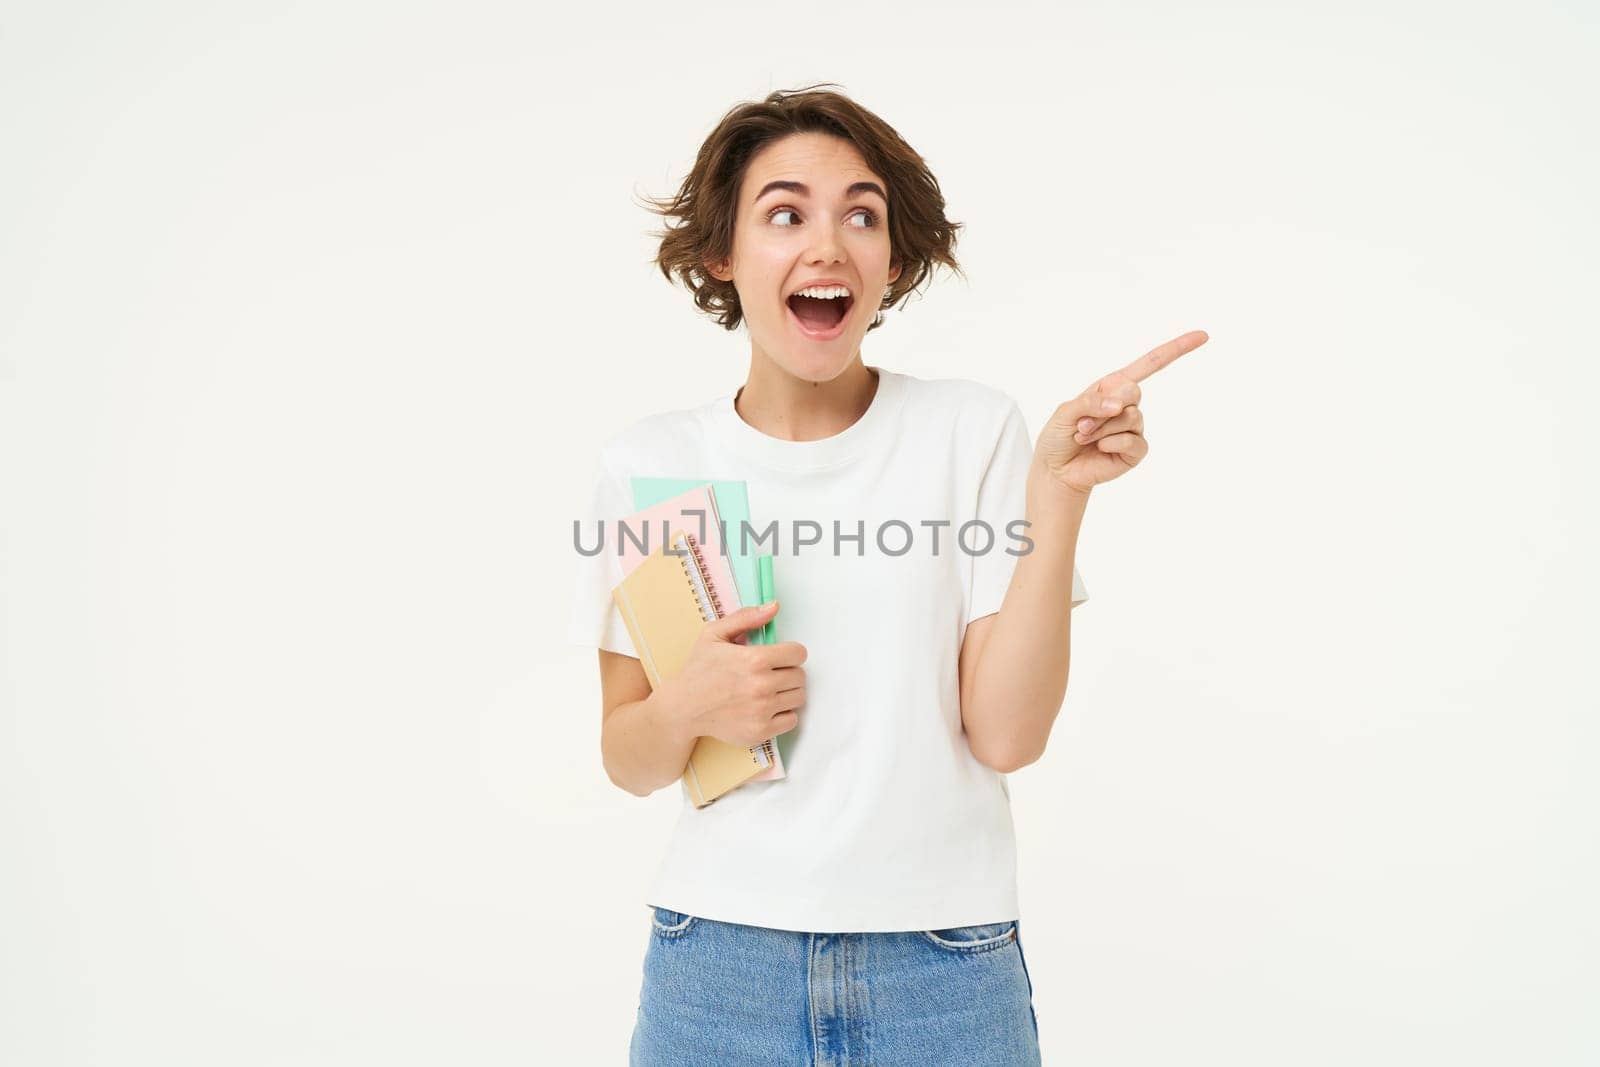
611;478;786;808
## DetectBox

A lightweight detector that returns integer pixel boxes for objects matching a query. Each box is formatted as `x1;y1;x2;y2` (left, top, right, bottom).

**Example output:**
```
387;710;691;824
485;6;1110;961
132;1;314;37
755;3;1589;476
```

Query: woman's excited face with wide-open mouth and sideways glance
710;133;901;382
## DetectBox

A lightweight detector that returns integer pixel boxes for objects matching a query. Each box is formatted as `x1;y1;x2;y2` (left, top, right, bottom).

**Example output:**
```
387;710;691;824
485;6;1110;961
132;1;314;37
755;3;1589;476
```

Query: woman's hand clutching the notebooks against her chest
662;600;805;749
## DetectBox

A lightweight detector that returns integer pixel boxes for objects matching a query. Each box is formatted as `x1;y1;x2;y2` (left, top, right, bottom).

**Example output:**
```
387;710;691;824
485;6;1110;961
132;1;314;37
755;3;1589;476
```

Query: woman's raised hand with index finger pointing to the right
1034;330;1210;496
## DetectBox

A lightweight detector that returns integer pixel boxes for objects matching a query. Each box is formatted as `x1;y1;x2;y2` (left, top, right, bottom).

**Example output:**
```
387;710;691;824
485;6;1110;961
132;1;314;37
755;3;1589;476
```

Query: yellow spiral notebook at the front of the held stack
611;530;765;808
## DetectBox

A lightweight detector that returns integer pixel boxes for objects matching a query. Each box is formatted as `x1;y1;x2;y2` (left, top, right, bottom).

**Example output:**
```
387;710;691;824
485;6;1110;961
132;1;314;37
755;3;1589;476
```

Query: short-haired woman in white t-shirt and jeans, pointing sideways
573;86;1205;1065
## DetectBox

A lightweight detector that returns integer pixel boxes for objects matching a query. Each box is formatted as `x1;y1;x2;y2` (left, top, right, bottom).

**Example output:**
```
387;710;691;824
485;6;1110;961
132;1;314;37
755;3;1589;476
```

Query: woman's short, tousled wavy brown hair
646;83;962;330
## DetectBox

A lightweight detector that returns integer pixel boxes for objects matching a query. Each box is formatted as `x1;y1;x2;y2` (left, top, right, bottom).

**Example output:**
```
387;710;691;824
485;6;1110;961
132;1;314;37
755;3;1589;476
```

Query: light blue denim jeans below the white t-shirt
629;907;1038;1067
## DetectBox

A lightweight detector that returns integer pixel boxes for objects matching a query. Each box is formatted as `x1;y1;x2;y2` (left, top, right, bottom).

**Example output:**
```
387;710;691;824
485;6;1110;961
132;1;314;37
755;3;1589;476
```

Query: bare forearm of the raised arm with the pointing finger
962;464;1088;769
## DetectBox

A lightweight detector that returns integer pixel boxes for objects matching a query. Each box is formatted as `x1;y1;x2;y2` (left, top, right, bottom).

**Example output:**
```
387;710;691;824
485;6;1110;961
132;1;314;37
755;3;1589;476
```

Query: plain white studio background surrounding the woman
0;2;1600;1067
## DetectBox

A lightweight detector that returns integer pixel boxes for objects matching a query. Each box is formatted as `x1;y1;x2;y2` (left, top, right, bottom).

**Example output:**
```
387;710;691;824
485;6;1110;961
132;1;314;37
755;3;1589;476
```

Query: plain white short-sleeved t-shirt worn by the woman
570;368;1088;933
